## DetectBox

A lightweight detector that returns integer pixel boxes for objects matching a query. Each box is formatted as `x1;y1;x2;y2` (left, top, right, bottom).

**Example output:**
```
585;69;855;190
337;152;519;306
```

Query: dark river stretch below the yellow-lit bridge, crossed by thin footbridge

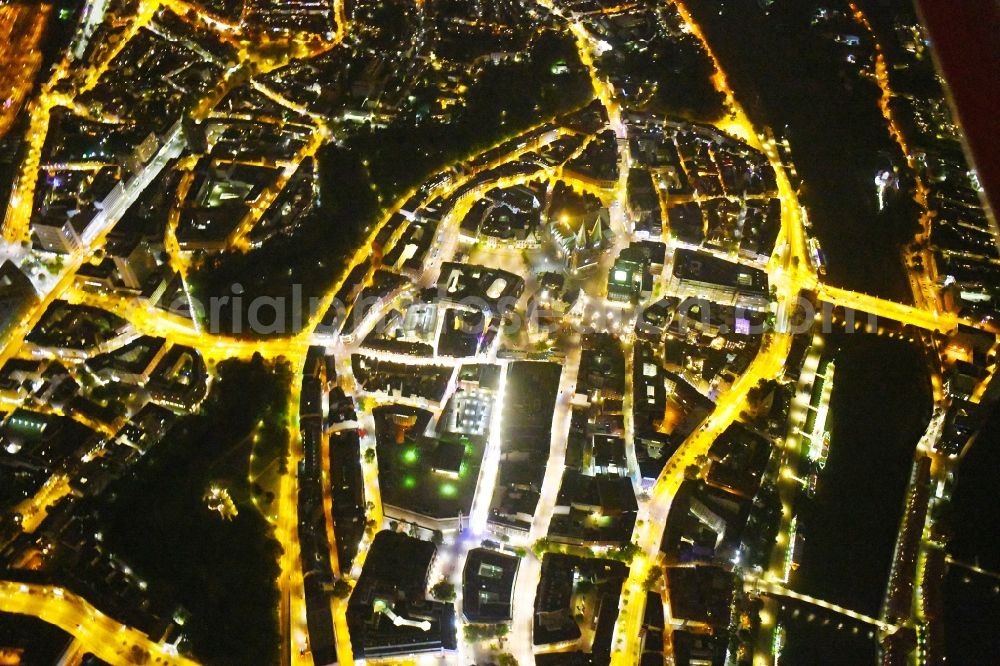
782;334;931;665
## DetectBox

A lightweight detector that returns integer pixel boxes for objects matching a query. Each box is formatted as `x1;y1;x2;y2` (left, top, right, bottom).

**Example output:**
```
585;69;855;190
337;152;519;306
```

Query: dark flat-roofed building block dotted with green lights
373;406;485;518
